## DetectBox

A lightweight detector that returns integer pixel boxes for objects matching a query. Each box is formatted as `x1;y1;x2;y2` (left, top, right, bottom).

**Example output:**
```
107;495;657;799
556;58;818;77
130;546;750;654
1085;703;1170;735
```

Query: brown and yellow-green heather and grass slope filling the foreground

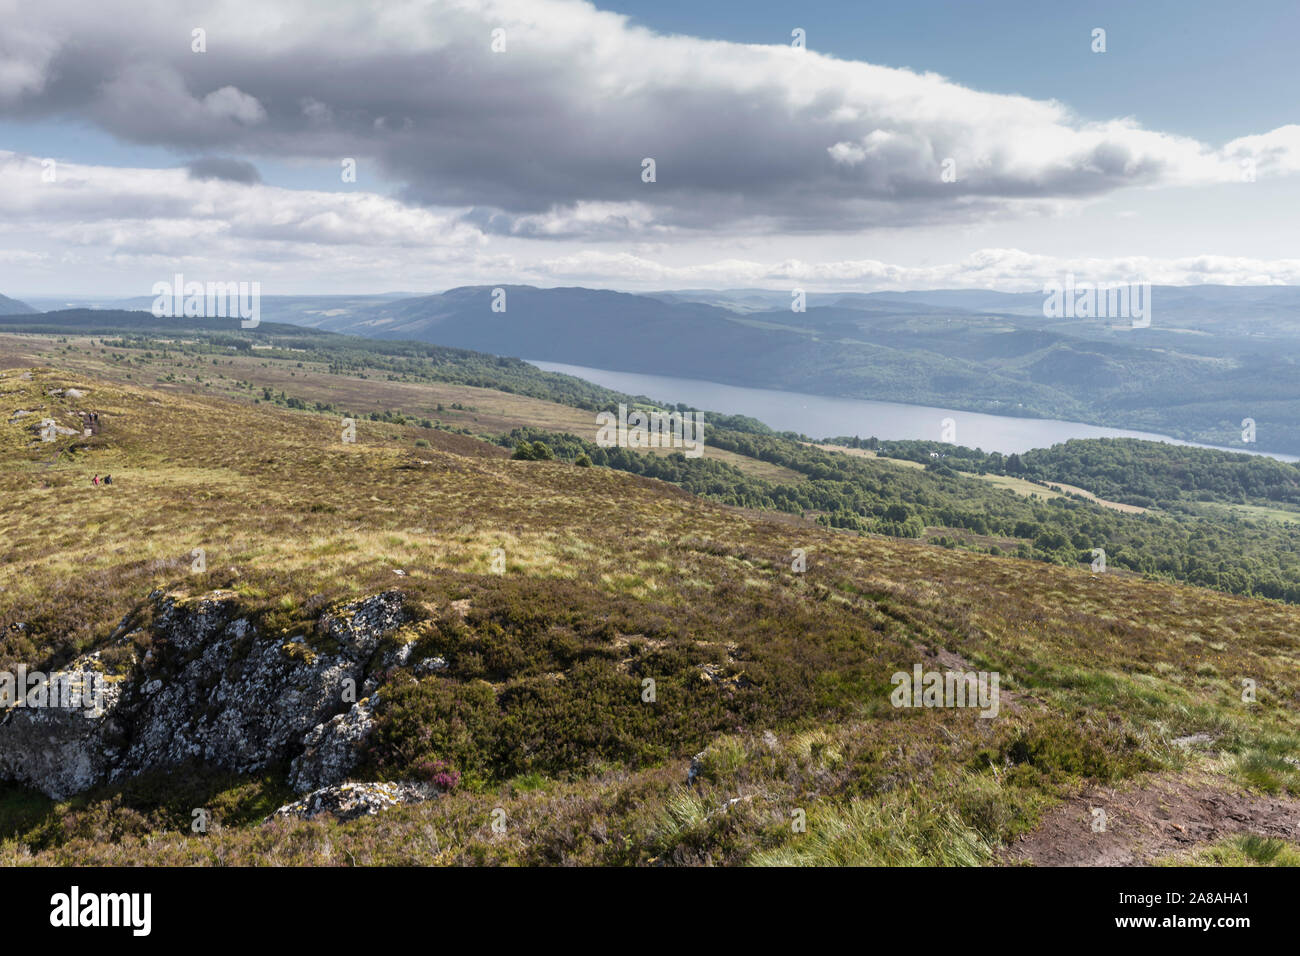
0;369;1300;864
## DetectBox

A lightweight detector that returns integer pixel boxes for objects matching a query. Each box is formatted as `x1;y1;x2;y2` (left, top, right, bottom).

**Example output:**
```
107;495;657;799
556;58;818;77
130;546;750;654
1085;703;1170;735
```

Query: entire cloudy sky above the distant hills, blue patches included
0;0;1300;298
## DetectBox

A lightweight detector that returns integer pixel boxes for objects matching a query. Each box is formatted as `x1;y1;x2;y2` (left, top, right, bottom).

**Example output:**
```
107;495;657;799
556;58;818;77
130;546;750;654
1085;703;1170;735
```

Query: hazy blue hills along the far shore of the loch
276;285;1300;454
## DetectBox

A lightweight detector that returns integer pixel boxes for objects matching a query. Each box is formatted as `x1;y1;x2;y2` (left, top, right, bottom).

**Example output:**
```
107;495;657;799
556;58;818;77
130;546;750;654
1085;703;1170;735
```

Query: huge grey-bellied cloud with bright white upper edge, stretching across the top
0;0;1300;241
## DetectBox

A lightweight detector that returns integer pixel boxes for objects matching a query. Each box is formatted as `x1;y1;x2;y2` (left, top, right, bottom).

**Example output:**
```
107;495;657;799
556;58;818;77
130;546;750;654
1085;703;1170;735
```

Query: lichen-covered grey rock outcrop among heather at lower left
0;592;410;799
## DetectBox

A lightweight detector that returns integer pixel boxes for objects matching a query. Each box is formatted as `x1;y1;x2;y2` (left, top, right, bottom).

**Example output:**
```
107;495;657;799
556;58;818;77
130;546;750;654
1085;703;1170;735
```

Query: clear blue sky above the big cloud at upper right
601;0;1300;140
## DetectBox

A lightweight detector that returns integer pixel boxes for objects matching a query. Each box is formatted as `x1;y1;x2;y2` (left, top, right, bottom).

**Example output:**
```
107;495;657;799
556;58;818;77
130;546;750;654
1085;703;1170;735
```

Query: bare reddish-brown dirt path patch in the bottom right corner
1001;777;1300;866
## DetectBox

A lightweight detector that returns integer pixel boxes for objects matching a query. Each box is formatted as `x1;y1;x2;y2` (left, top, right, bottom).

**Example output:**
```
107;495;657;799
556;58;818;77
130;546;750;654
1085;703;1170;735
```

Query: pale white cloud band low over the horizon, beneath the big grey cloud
0;152;1300;291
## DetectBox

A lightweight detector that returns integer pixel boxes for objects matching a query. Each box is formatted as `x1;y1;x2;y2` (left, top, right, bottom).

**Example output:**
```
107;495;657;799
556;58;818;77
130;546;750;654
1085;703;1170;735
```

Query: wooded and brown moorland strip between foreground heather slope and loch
0;321;1300;602
